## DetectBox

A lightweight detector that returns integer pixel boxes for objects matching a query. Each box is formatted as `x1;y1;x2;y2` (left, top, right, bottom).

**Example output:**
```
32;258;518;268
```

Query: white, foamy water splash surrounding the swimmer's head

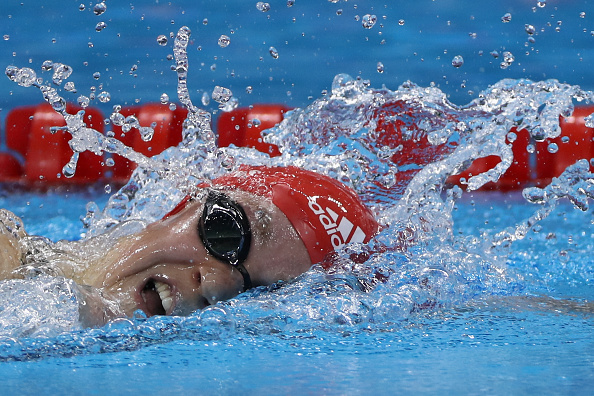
0;23;594;359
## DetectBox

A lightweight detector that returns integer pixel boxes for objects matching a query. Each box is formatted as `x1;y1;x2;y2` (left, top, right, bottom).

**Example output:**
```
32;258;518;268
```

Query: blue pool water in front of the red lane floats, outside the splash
1;192;594;394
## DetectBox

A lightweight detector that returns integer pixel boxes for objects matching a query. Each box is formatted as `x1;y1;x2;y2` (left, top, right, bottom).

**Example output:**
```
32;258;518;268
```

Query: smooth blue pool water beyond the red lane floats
0;0;594;113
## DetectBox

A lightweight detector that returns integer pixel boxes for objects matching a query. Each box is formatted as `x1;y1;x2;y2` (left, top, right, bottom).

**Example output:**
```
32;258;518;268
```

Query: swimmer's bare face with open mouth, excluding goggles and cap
92;191;311;316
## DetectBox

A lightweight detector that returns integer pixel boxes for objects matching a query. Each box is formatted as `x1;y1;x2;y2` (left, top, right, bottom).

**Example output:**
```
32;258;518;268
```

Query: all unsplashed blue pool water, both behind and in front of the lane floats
0;0;594;394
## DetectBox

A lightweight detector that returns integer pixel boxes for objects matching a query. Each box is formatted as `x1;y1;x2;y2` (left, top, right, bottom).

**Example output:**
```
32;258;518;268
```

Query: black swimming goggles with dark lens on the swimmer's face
198;190;252;292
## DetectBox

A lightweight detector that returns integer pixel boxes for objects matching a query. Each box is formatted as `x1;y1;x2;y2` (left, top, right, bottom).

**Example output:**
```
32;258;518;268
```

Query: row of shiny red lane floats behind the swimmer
0;102;594;190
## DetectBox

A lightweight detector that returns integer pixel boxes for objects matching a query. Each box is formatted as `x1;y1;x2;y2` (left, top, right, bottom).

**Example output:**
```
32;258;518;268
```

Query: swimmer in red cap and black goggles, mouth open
0;166;378;326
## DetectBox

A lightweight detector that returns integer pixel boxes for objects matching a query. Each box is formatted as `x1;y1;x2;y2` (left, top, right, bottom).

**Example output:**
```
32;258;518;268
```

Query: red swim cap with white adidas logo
212;166;379;266
